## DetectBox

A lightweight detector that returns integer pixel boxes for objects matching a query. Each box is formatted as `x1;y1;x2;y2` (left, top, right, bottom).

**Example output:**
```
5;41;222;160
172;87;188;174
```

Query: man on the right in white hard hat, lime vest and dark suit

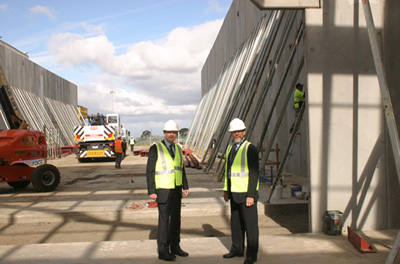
223;118;259;264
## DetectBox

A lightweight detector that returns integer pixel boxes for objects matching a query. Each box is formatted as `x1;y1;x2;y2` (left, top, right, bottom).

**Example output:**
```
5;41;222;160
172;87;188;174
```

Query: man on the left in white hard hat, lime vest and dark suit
146;120;189;261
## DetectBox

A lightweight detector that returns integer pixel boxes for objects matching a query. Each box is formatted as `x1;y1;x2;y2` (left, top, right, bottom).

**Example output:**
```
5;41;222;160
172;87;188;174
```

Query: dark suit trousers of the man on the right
231;199;259;258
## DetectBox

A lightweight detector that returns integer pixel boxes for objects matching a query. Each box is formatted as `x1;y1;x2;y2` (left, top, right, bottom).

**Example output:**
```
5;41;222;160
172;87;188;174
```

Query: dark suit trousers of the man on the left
157;187;182;255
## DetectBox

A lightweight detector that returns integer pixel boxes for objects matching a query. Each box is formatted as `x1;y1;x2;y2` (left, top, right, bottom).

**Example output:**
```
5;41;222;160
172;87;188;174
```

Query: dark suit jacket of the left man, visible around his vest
146;140;189;203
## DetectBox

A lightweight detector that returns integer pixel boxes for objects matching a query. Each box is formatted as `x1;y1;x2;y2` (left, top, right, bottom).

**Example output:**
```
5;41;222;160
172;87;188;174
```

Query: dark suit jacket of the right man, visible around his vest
228;144;260;203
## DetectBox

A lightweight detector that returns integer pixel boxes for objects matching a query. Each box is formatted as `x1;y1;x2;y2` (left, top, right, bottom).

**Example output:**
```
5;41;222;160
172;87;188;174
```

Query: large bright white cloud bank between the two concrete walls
49;20;222;134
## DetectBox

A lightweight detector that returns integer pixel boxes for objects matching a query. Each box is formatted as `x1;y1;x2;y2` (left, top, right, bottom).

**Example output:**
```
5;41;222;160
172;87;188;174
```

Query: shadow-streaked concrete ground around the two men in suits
0;152;400;264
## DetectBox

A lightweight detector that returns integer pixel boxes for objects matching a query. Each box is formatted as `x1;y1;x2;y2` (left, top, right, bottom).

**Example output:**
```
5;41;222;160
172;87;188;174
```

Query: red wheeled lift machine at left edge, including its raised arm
0;67;60;192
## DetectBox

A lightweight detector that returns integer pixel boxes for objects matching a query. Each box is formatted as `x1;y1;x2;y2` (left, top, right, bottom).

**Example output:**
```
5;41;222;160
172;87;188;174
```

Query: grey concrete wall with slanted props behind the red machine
0;41;80;146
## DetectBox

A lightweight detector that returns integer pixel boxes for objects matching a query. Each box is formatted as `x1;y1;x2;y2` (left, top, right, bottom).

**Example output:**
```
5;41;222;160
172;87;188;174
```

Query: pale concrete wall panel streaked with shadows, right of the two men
306;0;400;232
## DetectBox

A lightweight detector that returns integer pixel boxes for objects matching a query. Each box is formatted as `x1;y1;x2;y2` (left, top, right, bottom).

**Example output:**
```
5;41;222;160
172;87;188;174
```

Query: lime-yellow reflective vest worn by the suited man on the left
155;142;183;189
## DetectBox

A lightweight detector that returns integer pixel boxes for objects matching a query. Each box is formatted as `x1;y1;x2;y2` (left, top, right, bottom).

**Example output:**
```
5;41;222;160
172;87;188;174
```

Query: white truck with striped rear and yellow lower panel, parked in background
74;114;129;162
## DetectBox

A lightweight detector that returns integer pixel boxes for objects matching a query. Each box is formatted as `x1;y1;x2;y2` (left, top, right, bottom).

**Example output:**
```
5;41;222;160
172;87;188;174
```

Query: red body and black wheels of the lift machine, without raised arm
0;129;60;192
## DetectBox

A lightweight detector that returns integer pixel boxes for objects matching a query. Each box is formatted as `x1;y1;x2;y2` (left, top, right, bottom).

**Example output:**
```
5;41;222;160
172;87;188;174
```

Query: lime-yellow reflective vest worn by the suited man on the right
224;140;259;193
